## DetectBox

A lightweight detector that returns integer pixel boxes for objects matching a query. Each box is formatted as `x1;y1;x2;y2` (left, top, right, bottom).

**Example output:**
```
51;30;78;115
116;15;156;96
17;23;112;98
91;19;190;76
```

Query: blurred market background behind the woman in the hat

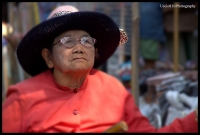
2;2;198;128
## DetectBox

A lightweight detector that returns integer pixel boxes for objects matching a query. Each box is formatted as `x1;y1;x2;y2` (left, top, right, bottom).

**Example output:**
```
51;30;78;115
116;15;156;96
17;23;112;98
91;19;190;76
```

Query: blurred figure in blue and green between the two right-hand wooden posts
139;2;166;70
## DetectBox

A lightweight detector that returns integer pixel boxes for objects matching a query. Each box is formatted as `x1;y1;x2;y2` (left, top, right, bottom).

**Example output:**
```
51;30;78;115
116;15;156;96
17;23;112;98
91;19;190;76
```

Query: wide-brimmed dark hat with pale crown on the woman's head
16;6;128;76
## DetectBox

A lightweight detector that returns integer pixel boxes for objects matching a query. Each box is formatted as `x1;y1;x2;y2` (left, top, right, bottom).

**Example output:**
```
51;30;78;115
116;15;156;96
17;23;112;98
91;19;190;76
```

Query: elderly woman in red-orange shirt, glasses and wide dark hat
2;6;198;132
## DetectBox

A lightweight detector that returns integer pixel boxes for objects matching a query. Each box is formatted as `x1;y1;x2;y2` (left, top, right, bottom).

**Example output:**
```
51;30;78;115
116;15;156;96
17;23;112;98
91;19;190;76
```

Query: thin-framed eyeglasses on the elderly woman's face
53;37;97;48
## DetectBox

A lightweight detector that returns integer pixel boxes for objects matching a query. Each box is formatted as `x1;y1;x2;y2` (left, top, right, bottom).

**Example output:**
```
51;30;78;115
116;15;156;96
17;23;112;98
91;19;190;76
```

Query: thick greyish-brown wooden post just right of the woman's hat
131;2;140;106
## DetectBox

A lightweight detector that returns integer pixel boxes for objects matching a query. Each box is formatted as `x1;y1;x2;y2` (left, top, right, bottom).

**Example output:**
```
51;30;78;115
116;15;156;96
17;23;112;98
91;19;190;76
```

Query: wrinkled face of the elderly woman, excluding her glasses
51;30;95;72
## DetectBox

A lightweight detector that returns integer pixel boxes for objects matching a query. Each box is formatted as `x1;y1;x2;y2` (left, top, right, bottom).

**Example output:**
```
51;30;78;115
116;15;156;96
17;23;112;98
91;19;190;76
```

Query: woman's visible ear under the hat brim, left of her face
42;48;53;68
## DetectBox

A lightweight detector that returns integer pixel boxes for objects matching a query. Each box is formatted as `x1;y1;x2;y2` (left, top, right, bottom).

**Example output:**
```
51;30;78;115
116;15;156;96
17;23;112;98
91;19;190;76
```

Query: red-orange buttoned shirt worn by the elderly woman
2;69;198;132
